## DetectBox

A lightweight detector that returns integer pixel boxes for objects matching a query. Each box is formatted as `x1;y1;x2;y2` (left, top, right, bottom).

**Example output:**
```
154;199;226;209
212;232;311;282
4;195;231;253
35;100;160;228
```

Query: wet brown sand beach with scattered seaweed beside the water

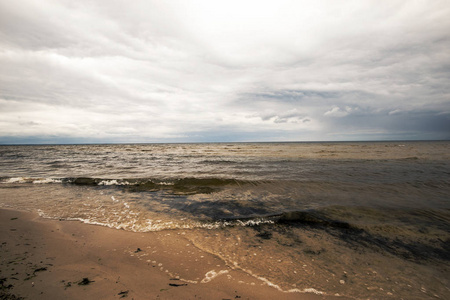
0;209;340;300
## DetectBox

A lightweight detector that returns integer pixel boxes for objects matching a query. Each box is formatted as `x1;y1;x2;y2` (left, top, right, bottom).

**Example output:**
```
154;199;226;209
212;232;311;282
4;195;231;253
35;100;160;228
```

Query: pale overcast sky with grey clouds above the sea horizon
0;0;450;144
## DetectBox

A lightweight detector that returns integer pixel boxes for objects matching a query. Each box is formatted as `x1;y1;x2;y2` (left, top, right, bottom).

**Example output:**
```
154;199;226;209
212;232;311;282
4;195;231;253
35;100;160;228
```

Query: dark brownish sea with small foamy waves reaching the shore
0;141;450;299
